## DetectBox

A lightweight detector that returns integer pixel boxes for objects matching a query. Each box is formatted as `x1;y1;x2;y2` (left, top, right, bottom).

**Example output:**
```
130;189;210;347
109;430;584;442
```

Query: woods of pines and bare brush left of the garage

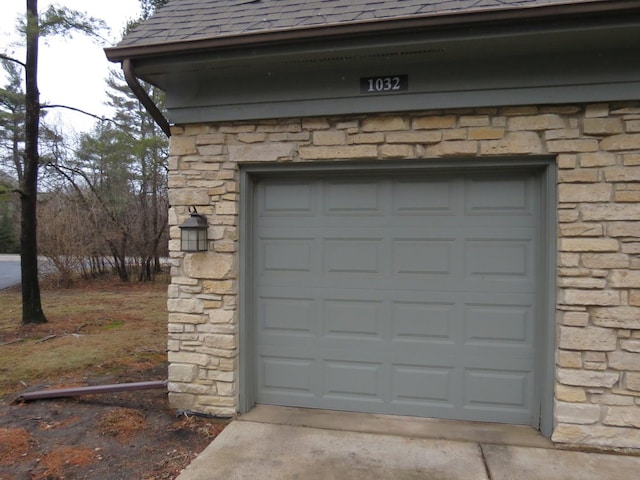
0;0;168;323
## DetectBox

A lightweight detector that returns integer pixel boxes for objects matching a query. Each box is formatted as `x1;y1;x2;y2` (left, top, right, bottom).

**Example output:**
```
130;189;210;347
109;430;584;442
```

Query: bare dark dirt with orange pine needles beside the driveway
0;366;226;480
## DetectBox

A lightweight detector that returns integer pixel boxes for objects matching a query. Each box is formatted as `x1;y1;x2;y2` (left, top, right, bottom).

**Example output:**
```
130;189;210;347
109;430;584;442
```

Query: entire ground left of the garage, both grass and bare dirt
0;280;228;480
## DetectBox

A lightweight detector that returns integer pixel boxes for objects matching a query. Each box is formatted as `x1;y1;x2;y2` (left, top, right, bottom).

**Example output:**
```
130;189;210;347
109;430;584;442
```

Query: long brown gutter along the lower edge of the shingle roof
105;0;640;62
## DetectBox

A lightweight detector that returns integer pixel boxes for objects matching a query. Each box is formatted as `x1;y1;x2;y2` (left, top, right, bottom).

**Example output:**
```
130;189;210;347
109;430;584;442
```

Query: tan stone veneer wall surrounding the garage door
168;102;640;448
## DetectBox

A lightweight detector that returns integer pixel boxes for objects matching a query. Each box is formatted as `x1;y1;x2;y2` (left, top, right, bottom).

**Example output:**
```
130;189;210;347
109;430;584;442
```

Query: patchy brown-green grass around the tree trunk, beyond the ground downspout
0;279;167;399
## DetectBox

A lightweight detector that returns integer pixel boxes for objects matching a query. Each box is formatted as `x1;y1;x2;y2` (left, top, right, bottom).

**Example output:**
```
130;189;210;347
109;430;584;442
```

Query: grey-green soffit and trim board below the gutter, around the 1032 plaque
130;18;640;124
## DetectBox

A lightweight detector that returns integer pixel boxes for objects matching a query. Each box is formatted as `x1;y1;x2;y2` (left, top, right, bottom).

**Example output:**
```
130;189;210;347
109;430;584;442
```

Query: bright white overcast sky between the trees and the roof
0;0;140;130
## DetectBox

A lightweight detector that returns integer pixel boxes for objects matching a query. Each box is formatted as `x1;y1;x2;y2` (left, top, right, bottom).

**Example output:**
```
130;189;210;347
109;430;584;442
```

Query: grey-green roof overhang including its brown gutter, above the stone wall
106;0;640;127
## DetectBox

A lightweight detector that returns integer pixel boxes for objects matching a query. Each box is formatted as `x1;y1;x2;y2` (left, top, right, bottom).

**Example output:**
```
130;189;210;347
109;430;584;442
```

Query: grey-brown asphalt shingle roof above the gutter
118;0;593;47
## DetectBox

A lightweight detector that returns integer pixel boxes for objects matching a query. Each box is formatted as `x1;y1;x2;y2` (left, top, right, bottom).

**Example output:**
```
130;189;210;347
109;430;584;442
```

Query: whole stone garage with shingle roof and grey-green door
106;0;640;449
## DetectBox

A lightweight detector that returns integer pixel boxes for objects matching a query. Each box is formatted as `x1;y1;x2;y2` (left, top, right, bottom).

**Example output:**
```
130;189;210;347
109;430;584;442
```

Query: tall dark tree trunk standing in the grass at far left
20;0;47;324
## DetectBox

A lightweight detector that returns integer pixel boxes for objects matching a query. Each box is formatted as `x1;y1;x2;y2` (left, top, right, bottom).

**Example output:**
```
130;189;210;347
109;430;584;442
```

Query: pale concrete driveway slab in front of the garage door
177;406;640;480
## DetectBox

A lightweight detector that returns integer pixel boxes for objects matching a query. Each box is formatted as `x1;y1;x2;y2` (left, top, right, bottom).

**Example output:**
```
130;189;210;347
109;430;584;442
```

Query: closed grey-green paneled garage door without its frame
252;172;540;425
